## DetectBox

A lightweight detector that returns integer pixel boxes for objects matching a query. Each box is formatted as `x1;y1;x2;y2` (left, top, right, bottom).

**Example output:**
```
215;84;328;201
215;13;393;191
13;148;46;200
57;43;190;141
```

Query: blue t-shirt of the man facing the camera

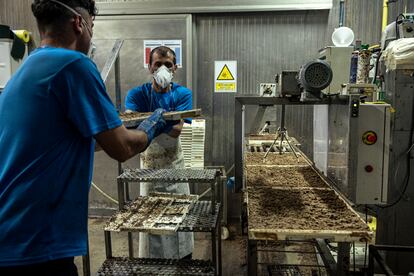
125;82;193;123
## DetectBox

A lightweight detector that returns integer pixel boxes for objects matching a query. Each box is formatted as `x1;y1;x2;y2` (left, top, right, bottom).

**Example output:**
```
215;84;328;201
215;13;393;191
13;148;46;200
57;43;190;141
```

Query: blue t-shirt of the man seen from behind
0;47;121;266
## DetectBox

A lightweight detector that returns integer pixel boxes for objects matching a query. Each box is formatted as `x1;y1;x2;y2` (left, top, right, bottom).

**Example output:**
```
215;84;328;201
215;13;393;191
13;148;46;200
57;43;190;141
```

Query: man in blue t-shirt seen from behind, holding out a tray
0;0;166;276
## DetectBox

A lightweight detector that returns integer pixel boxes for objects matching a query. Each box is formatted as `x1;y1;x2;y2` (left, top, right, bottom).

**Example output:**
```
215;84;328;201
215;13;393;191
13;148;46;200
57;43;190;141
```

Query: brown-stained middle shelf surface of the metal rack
105;193;220;234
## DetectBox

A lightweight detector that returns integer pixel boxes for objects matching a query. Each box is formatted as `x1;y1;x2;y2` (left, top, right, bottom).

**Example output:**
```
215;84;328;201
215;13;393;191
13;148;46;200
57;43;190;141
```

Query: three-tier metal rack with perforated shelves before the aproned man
97;168;223;276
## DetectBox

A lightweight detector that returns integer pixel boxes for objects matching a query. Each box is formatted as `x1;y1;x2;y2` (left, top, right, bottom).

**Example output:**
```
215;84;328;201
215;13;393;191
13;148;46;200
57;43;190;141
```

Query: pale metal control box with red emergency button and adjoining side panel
326;103;391;204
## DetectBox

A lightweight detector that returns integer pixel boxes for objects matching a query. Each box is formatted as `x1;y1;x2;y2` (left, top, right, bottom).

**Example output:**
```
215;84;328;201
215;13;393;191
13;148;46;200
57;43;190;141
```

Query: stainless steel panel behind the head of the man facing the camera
90;15;192;208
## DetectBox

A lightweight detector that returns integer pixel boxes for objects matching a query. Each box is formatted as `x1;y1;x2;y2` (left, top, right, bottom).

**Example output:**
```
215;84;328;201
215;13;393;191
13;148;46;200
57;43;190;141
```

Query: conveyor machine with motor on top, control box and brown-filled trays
235;51;391;275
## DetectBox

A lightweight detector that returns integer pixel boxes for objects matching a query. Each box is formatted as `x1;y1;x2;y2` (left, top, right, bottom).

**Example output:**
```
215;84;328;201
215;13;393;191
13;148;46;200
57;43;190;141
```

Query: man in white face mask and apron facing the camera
125;46;194;259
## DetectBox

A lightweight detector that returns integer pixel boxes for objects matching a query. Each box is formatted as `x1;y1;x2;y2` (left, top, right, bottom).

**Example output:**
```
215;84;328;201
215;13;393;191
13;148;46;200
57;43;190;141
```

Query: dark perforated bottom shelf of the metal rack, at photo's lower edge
96;257;214;276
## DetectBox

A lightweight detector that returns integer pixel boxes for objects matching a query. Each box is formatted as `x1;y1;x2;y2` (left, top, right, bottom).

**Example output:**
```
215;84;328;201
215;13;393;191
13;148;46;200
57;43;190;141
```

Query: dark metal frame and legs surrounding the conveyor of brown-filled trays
234;96;359;275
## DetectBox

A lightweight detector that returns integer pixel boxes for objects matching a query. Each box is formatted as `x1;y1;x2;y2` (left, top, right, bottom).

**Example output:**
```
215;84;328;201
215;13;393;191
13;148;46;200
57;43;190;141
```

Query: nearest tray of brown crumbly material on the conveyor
247;187;372;242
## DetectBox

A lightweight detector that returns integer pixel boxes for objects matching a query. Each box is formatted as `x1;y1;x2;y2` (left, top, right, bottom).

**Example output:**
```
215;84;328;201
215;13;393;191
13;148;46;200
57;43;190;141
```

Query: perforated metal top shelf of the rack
118;169;218;182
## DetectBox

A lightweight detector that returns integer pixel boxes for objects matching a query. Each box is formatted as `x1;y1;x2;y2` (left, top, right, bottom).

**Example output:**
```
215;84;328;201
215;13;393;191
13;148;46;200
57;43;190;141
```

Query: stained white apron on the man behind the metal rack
138;133;194;259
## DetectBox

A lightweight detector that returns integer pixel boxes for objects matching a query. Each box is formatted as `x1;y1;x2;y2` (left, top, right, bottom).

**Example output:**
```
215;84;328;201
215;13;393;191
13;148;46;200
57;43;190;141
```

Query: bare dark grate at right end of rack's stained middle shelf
178;201;220;232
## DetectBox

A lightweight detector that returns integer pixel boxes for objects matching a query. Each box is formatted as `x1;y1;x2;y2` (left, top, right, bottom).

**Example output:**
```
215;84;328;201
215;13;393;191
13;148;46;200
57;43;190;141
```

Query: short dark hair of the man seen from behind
32;0;98;28
